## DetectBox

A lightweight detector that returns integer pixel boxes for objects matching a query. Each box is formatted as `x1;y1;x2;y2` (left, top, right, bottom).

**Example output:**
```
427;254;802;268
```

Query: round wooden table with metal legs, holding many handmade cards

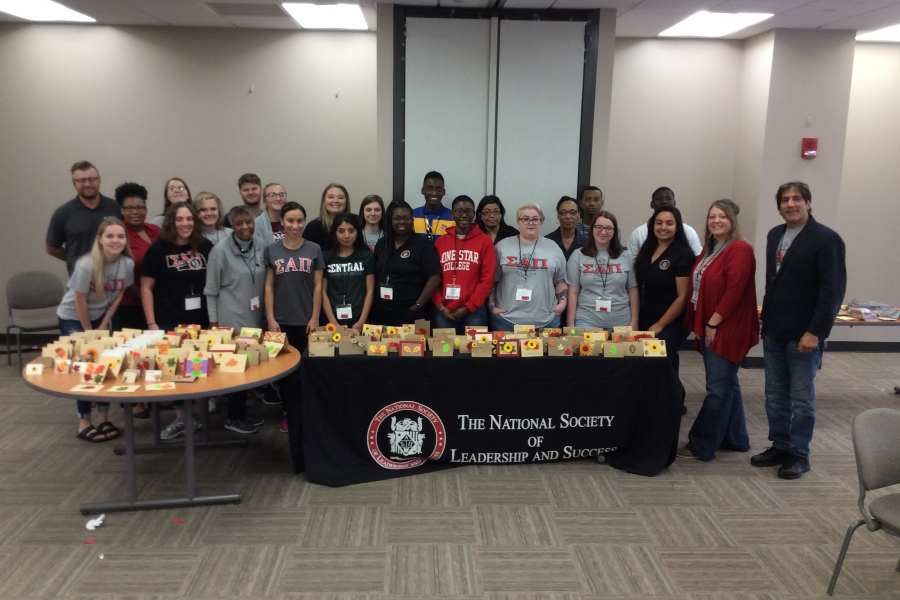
22;346;300;515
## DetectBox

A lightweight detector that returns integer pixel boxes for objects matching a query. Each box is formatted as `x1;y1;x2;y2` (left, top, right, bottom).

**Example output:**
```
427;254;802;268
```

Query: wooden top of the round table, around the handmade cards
22;345;300;402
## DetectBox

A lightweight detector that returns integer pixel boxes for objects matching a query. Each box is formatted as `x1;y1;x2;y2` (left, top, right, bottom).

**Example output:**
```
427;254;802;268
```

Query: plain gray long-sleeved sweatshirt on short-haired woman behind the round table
203;235;266;327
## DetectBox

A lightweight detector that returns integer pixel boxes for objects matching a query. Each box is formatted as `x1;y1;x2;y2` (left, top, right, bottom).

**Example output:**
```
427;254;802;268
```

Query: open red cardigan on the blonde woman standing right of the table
684;240;759;364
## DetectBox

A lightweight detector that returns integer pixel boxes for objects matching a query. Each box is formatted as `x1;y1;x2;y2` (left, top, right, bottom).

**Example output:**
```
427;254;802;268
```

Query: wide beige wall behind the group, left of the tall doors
0;25;374;328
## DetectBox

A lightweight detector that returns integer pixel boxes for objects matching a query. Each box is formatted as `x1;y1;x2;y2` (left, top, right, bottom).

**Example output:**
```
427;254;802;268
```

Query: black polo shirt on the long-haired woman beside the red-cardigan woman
634;244;696;324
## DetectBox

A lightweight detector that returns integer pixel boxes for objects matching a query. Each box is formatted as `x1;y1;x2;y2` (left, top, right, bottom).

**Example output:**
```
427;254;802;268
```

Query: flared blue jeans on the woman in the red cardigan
688;347;750;460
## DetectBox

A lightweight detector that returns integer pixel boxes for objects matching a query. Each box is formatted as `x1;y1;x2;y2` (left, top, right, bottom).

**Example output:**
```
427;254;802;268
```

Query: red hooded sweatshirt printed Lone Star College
432;224;497;312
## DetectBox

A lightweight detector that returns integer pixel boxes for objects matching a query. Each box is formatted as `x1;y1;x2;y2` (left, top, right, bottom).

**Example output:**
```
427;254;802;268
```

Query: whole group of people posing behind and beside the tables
47;162;846;478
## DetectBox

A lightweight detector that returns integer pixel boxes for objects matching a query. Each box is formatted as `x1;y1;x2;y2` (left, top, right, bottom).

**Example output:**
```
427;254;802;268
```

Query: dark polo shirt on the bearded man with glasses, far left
47;194;122;274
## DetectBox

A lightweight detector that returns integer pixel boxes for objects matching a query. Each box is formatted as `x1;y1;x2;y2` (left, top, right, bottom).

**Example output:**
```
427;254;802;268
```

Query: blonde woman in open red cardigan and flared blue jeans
678;200;759;461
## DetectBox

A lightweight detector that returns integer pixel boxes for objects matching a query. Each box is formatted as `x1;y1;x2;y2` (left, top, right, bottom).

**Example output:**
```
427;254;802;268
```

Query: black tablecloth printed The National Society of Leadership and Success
288;356;681;486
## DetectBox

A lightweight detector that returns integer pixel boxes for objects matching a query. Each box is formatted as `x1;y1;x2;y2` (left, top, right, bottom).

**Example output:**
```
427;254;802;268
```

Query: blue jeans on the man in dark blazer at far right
763;336;822;459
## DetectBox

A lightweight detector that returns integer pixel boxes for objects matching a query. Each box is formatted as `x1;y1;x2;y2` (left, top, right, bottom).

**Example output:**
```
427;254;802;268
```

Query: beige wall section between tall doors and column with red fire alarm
594;38;742;235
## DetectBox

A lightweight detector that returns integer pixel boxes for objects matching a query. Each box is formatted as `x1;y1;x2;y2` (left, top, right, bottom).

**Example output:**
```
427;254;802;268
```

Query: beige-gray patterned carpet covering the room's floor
0;353;900;600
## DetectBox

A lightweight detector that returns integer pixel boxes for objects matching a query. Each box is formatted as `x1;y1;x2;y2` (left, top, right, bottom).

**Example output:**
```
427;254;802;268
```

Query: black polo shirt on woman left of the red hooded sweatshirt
375;235;441;307
